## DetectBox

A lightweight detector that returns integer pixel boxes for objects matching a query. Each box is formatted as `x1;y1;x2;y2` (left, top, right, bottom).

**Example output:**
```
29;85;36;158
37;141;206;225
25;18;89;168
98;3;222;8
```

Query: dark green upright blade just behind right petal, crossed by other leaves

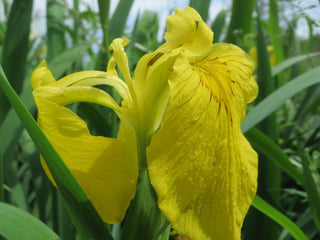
245;13;281;240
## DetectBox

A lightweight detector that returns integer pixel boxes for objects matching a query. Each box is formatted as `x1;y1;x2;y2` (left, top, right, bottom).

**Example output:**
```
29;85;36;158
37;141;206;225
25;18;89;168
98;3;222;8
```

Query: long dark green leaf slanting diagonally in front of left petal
0;67;112;239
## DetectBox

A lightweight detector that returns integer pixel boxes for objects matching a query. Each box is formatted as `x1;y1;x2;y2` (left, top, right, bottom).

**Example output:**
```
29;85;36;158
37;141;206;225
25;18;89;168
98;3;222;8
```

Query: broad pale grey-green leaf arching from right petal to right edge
241;67;320;132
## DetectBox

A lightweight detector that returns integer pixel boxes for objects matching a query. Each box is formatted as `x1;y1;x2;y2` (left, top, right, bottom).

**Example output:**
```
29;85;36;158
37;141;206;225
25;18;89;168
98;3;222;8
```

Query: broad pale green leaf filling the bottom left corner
0;203;60;240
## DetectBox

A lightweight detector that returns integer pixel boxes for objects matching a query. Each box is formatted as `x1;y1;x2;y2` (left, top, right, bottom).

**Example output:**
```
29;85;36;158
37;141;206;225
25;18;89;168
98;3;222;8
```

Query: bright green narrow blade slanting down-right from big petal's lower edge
252;196;308;240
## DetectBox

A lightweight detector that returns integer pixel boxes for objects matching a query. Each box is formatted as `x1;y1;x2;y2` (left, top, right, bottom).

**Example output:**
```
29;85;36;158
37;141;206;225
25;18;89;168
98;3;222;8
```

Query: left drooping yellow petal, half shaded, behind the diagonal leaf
35;87;137;223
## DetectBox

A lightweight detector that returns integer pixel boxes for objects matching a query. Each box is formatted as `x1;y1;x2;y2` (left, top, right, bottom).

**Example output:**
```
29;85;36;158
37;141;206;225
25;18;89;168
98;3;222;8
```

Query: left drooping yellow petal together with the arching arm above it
32;65;138;224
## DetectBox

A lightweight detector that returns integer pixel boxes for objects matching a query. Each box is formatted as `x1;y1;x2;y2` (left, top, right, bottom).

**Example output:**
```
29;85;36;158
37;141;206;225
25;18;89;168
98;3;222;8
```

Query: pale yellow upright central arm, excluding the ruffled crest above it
134;47;179;137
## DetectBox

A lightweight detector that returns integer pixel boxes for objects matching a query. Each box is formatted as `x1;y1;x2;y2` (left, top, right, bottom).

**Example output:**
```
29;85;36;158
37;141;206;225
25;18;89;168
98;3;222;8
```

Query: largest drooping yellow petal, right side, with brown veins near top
147;44;257;240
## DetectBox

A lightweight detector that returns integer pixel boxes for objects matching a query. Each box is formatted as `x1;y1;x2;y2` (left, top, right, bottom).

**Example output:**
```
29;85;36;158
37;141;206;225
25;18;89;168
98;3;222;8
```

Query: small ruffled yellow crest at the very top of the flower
164;7;213;52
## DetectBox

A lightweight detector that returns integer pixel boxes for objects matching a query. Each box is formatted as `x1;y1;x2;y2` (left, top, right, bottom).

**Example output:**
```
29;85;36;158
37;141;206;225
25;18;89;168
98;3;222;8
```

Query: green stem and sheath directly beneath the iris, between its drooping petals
120;134;170;240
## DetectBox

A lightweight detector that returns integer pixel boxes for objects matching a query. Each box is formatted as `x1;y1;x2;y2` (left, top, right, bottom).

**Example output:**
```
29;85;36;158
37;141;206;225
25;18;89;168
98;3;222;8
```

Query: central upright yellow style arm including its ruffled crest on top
133;7;213;139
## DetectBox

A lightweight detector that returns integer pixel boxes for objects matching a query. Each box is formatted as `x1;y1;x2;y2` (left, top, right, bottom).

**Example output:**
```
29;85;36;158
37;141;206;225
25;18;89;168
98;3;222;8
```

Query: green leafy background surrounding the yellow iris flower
0;0;320;240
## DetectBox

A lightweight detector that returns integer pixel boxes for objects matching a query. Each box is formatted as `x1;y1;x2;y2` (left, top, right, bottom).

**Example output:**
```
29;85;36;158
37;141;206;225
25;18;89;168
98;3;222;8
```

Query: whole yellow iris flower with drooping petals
31;7;258;240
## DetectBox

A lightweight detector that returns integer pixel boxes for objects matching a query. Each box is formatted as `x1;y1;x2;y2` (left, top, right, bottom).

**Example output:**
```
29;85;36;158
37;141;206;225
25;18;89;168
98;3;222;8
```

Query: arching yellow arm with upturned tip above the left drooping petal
31;60;137;130
